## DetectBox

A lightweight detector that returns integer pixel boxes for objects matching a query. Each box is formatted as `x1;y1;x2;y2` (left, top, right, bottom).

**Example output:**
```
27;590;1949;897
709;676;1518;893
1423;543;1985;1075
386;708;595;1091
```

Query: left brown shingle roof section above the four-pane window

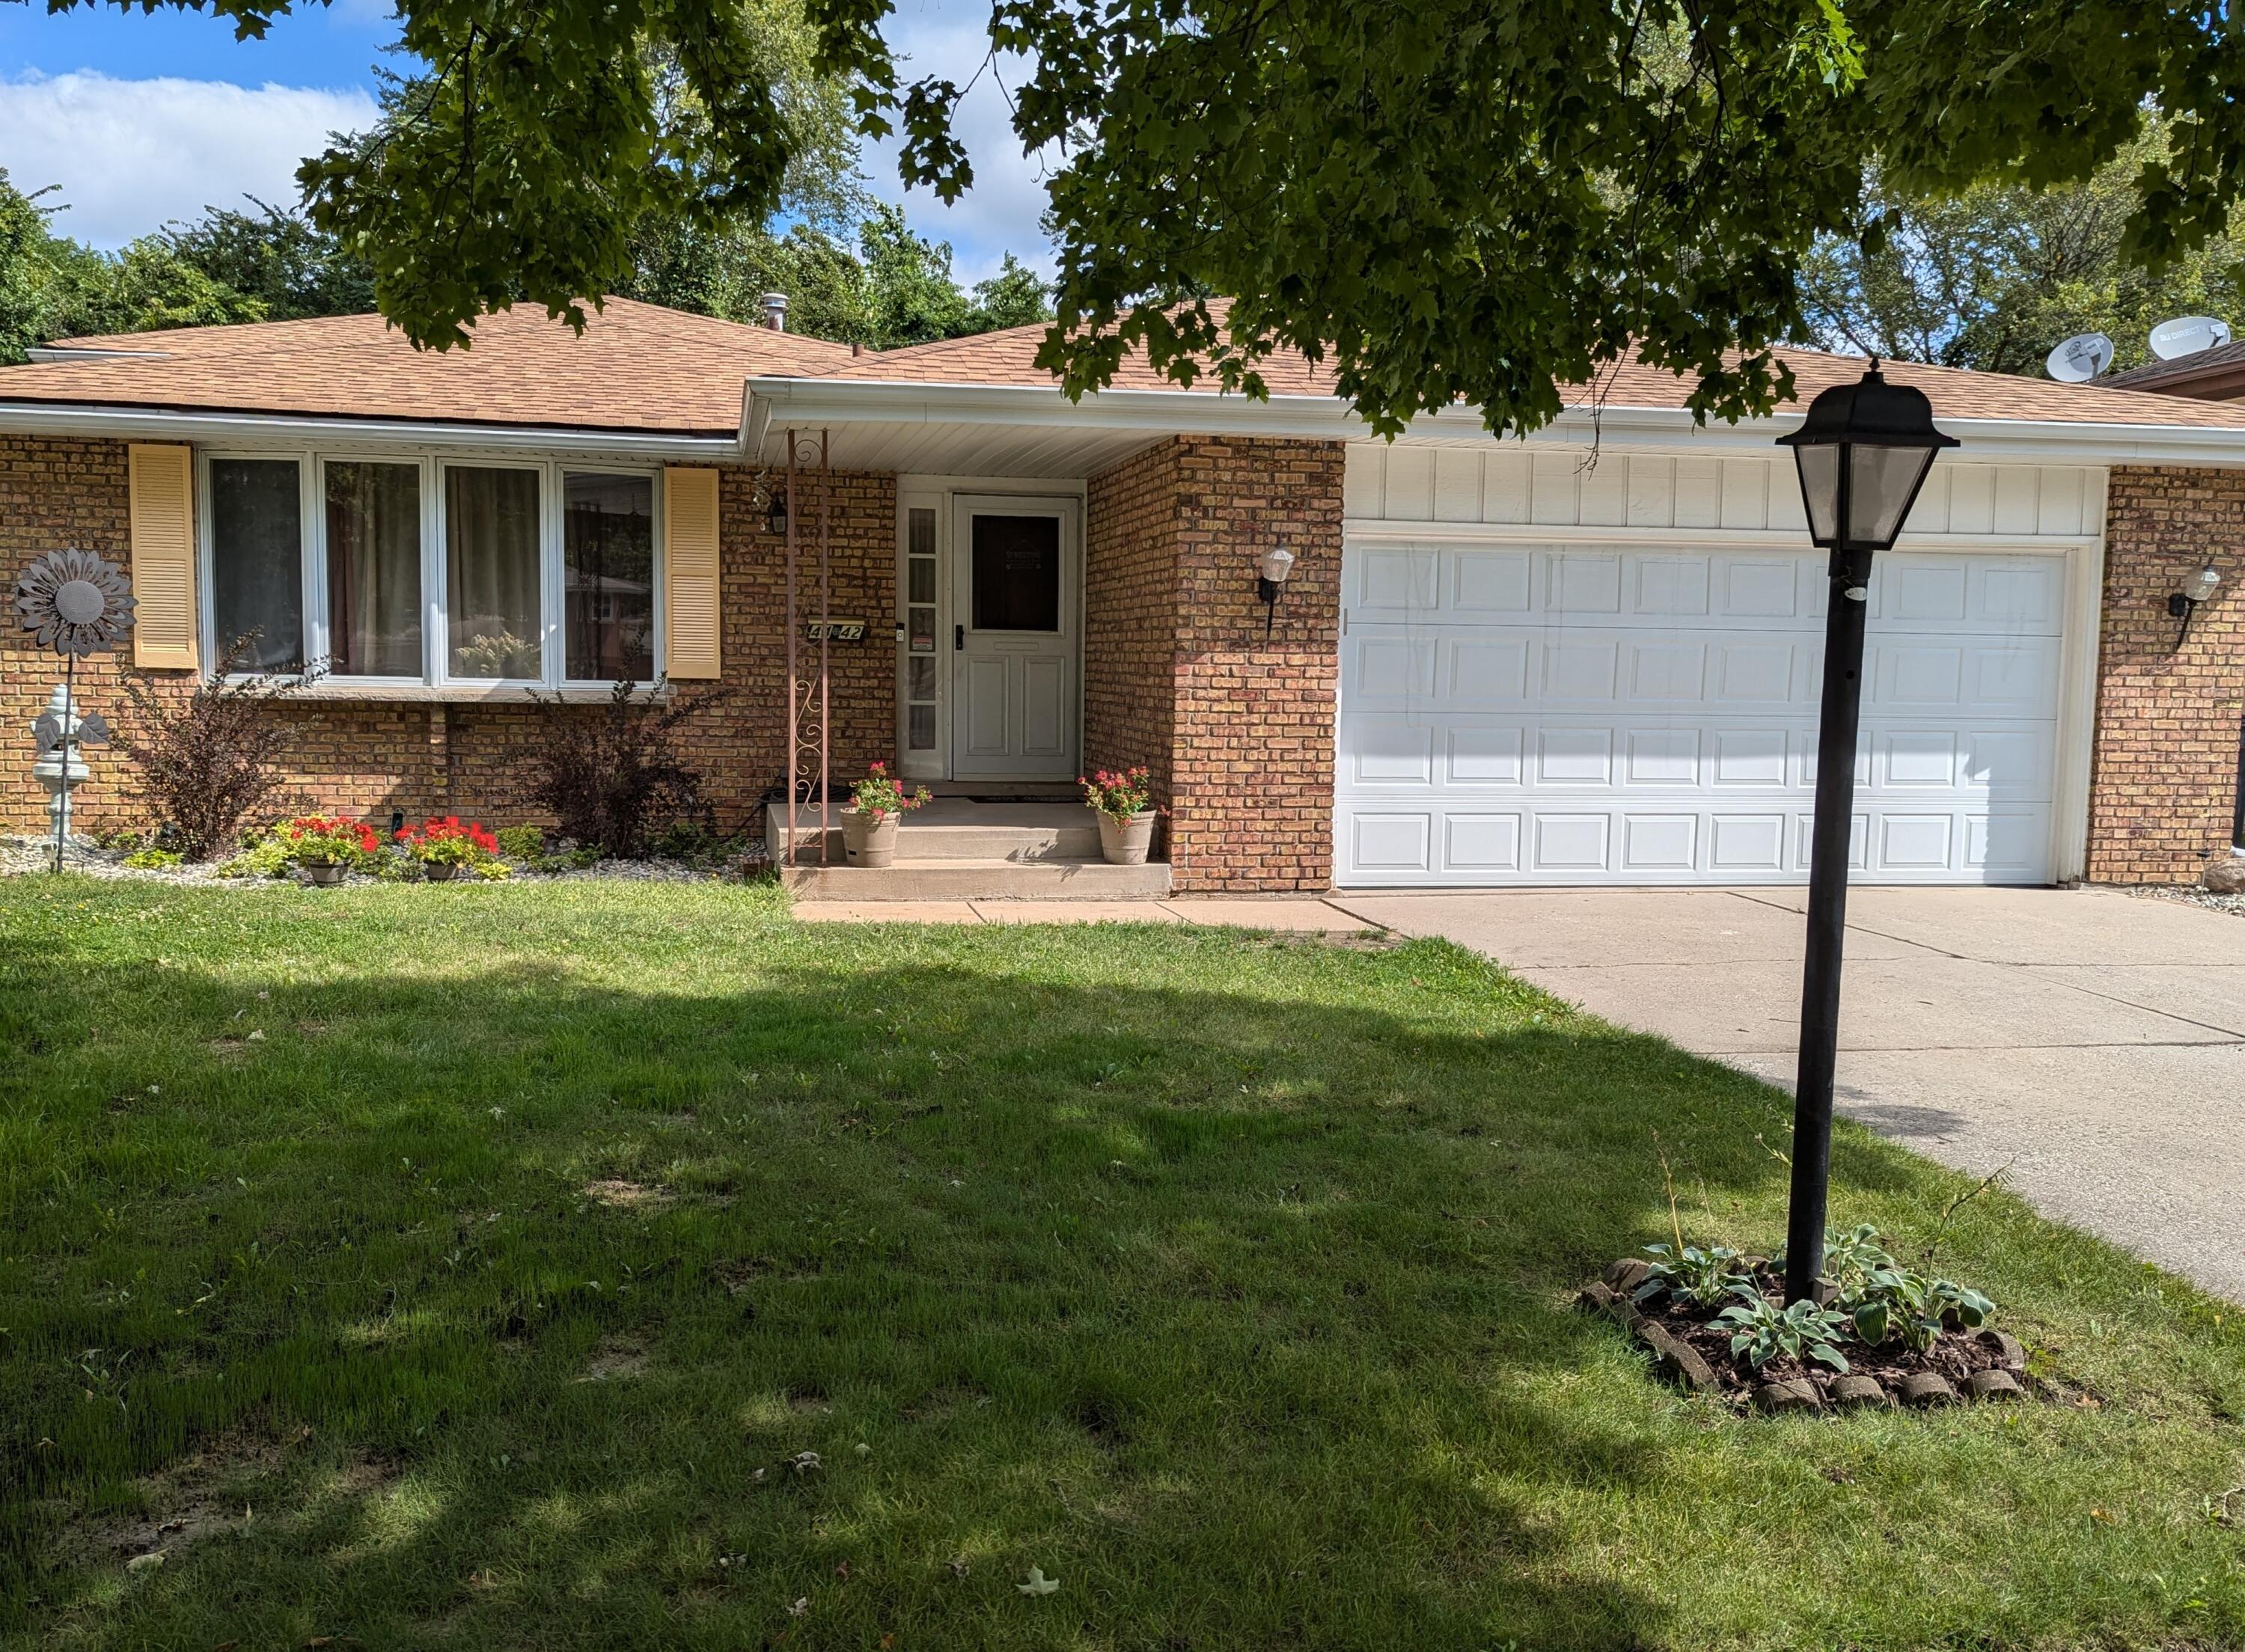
0;299;851;435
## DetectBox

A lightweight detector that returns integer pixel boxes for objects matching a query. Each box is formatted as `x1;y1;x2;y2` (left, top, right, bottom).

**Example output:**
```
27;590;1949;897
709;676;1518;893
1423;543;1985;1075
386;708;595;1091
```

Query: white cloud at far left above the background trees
0;70;375;247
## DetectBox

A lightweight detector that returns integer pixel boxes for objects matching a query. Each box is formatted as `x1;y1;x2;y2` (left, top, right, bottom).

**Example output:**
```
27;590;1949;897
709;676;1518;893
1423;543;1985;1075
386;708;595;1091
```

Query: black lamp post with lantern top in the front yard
1778;357;1958;1302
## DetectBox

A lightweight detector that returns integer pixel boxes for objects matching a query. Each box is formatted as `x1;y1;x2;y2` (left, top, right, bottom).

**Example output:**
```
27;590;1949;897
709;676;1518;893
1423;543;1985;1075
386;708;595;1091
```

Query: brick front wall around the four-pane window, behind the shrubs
0;435;896;833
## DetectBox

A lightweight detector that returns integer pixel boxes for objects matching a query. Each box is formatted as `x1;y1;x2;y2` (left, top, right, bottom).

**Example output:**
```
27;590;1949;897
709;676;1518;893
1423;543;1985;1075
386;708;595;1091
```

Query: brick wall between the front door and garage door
1084;435;1343;891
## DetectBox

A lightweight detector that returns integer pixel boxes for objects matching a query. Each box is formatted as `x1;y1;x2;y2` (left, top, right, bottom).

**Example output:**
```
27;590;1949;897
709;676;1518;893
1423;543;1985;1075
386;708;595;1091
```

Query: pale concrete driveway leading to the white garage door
1331;889;2245;1302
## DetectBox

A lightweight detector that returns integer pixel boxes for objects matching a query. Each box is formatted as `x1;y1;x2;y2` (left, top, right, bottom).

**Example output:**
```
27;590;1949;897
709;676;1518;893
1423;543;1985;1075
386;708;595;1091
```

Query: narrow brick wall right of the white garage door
2088;465;2245;884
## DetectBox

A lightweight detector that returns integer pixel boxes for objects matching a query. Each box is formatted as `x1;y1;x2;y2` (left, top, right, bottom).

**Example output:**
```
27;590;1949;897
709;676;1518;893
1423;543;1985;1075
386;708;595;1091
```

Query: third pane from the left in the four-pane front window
445;465;543;678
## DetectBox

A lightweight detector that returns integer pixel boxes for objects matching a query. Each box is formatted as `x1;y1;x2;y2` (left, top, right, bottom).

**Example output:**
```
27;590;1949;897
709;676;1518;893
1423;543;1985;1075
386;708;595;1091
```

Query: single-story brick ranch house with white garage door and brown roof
0;301;2245;891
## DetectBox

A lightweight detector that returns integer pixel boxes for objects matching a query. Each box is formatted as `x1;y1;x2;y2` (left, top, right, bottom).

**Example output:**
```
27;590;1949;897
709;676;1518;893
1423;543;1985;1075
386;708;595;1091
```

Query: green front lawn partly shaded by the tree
0;878;2245;1652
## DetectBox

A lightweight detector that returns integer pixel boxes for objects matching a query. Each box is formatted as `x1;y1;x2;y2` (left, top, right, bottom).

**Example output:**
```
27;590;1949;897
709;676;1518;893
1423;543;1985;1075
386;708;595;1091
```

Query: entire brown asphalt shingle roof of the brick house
13;299;2245;435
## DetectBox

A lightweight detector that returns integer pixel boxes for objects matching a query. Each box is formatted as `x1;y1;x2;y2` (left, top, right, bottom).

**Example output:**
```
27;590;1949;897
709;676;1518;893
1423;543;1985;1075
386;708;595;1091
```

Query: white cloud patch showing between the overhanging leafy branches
864;0;1053;283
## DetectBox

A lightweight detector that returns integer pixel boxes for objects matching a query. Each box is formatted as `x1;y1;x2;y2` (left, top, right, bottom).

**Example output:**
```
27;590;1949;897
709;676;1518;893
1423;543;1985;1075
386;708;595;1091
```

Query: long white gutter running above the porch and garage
743;377;2245;467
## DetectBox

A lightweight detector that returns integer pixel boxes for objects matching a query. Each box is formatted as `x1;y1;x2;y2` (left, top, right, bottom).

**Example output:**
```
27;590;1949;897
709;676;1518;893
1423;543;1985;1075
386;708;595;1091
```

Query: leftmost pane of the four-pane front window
211;458;303;671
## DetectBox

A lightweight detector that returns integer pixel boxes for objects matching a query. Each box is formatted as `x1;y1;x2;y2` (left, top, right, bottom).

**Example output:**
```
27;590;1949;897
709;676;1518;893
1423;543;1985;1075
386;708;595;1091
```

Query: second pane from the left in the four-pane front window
326;460;422;678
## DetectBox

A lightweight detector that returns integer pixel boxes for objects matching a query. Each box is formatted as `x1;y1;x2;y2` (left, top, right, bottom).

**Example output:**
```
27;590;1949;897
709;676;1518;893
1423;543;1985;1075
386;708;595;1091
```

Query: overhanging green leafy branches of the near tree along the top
39;0;2245;431
